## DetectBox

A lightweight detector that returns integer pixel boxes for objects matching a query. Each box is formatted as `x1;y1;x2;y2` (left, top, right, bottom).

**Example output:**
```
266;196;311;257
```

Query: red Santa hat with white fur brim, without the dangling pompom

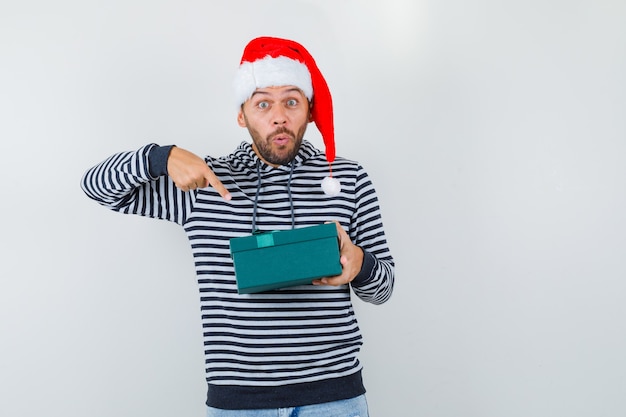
233;37;335;165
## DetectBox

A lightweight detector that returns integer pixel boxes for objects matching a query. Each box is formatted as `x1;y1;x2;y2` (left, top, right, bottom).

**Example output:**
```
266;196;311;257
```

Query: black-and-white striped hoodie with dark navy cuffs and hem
81;140;394;409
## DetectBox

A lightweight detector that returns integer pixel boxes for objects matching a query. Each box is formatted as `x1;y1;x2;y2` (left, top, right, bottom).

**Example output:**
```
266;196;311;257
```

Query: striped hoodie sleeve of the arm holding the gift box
349;166;395;304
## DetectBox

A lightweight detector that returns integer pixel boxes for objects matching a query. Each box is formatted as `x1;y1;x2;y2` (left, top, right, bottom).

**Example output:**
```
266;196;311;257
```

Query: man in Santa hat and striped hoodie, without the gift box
82;37;394;417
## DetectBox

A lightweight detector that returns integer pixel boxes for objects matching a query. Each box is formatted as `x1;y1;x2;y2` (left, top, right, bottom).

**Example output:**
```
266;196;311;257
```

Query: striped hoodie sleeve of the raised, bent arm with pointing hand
81;143;194;224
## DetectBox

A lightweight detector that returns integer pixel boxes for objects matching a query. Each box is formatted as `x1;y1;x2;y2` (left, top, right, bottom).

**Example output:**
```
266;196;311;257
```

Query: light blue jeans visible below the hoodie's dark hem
207;395;369;417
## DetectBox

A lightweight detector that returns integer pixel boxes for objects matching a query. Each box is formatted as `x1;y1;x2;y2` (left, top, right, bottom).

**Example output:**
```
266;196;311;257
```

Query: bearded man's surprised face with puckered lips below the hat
237;86;311;166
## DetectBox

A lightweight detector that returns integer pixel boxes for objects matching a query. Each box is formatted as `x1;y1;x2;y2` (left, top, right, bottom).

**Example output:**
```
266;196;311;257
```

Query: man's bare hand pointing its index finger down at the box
167;146;231;200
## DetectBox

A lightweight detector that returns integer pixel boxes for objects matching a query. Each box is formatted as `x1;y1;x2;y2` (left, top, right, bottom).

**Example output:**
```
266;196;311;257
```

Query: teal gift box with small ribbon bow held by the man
230;223;341;294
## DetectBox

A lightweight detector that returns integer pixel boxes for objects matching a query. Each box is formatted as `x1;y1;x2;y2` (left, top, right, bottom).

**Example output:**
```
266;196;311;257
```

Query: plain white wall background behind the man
0;0;626;417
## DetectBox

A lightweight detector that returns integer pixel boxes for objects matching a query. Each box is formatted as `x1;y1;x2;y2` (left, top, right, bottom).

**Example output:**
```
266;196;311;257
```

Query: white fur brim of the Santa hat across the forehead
233;55;313;106
